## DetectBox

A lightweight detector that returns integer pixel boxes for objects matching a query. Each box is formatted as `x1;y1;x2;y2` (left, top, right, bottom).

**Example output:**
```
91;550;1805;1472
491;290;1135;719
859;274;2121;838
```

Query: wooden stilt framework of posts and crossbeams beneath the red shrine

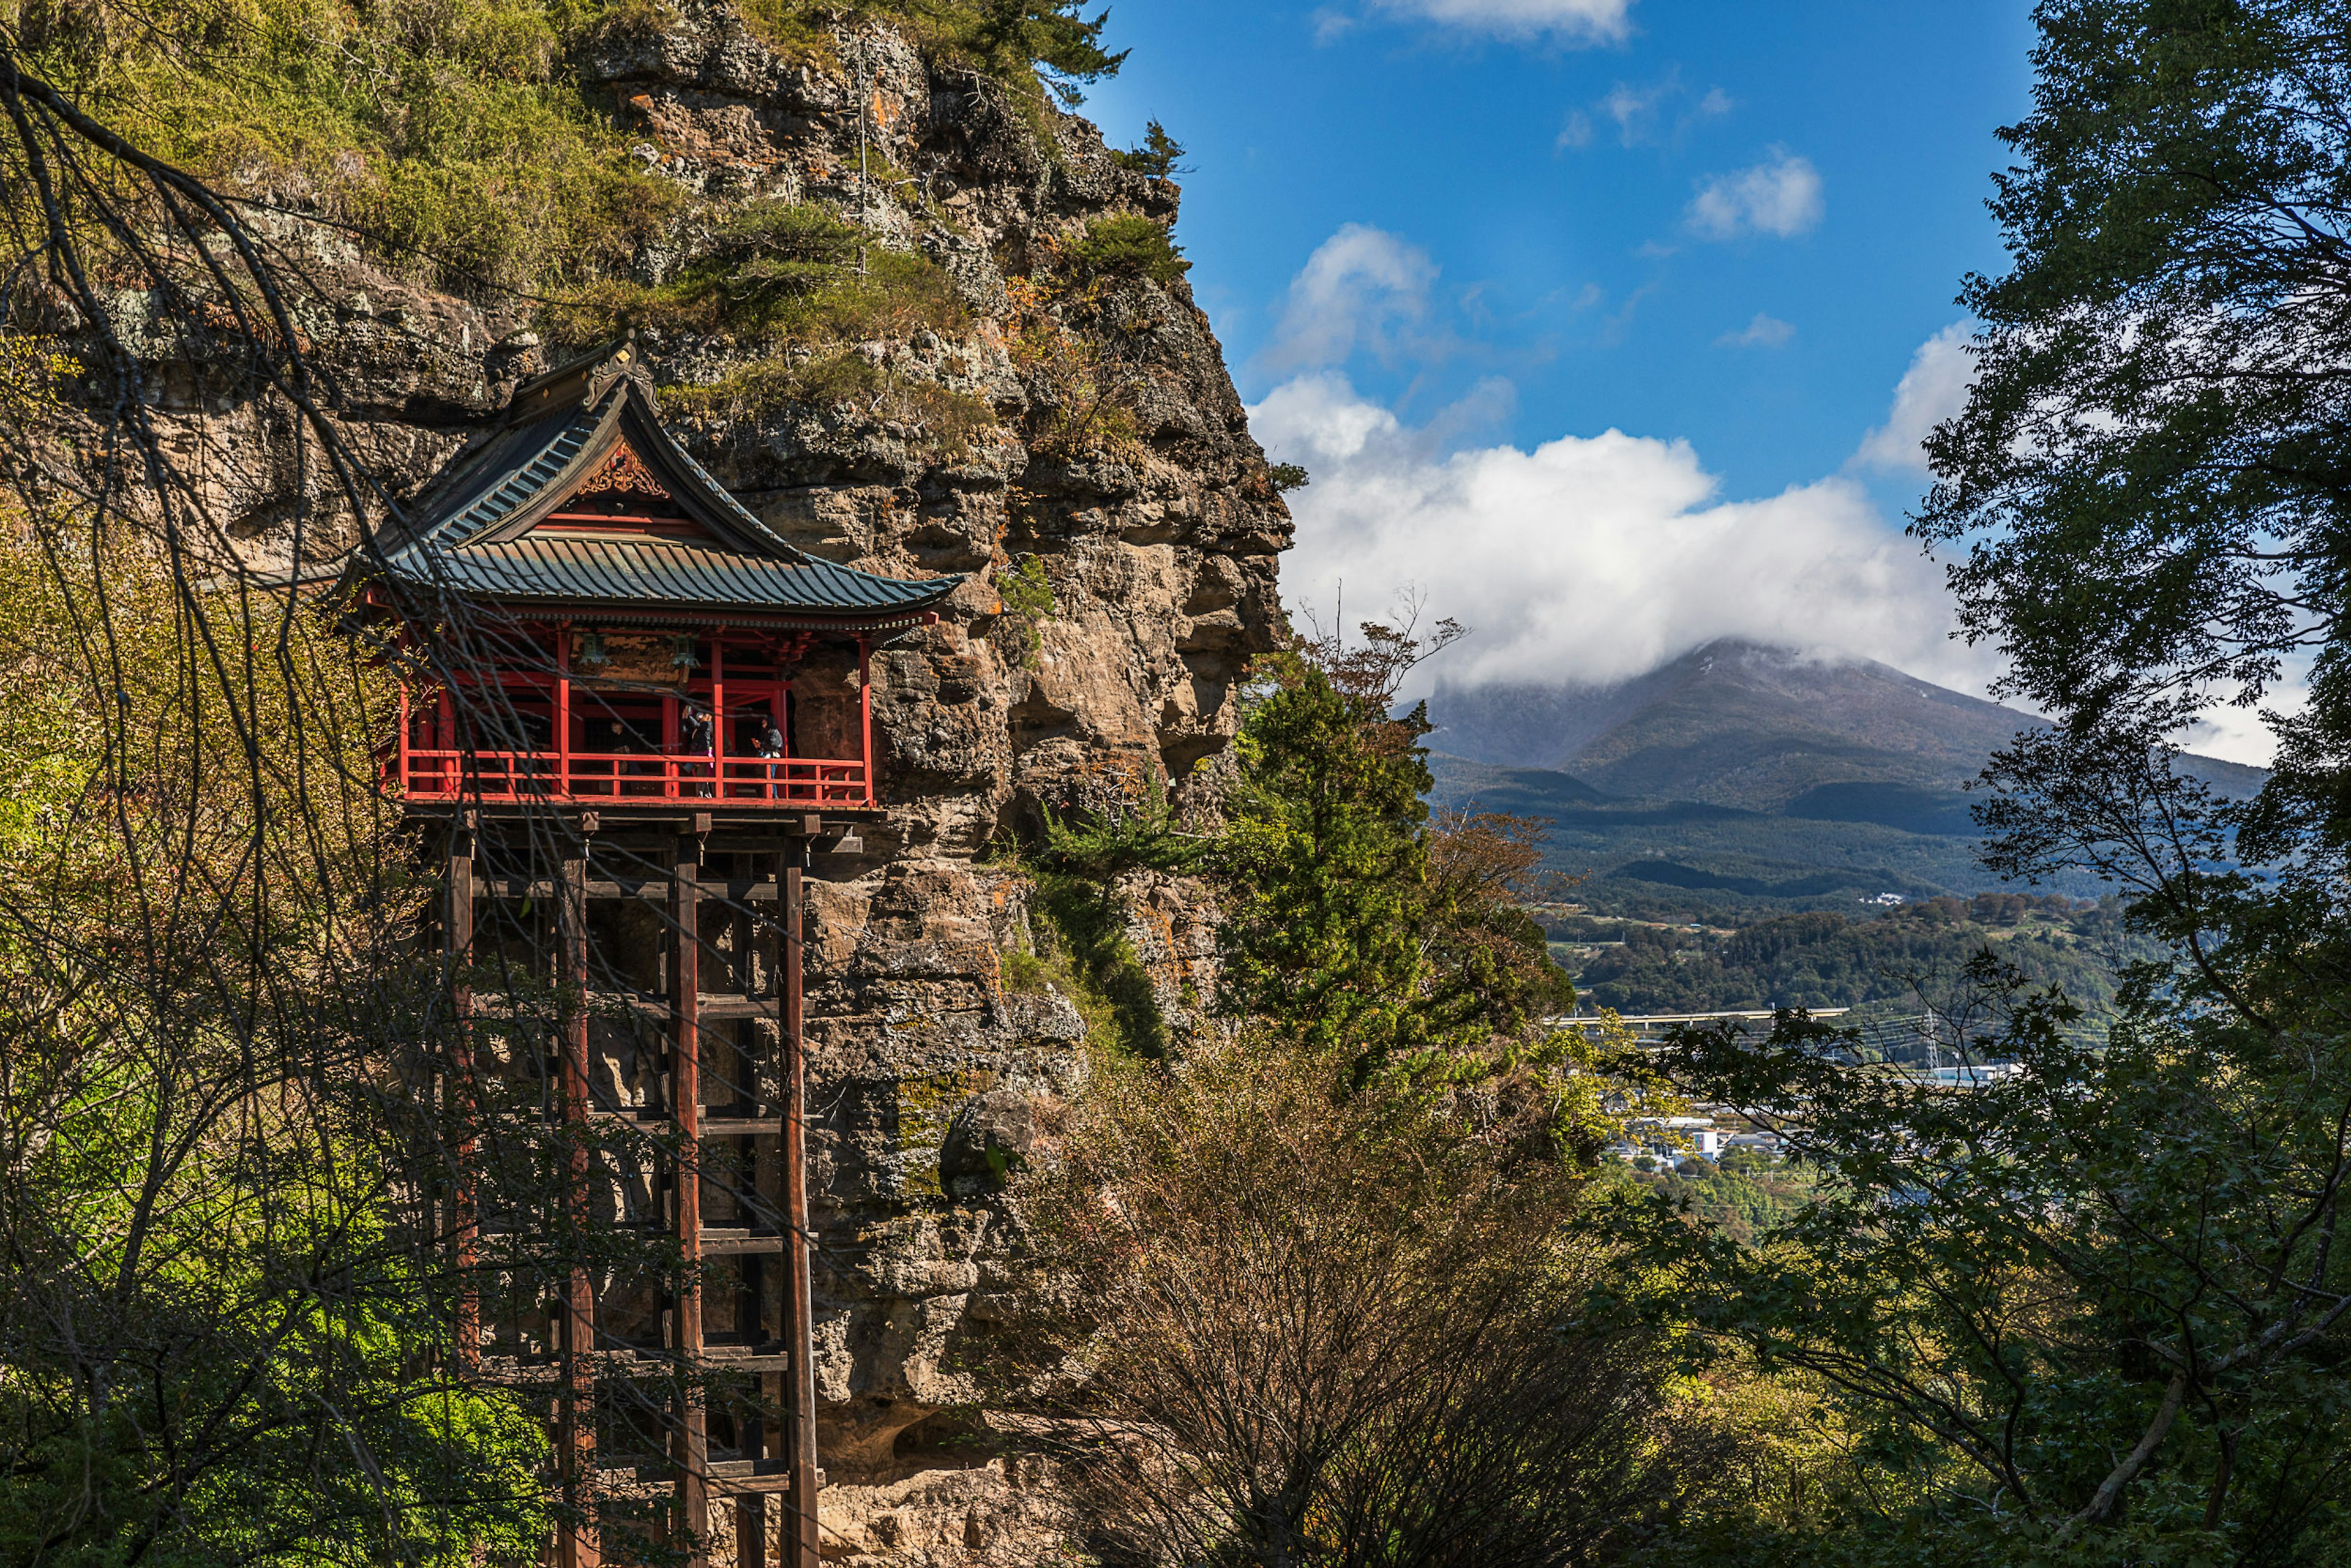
444;813;823;1568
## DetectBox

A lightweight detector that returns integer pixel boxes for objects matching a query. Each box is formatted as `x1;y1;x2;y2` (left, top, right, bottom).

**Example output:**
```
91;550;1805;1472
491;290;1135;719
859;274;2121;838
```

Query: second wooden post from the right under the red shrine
670;818;710;1568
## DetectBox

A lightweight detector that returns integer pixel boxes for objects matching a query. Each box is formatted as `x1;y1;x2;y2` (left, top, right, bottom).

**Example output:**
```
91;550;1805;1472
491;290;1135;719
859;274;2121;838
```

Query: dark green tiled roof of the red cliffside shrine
381;348;964;623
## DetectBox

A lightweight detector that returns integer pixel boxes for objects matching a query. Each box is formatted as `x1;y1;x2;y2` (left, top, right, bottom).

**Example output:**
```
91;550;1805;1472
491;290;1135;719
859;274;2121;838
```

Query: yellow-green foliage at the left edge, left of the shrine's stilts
0;515;546;1566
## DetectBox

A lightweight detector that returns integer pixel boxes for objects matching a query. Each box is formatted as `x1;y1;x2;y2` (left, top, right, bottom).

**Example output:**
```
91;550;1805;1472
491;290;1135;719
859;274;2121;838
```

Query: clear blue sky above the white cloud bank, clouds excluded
1086;0;2031;506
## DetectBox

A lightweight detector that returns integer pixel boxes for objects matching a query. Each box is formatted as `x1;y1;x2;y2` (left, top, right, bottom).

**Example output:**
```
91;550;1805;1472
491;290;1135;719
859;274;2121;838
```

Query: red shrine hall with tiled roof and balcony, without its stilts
381;345;962;813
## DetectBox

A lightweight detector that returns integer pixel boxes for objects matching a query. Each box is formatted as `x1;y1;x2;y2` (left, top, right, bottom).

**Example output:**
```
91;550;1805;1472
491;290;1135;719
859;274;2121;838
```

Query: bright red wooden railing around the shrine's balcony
400;748;872;806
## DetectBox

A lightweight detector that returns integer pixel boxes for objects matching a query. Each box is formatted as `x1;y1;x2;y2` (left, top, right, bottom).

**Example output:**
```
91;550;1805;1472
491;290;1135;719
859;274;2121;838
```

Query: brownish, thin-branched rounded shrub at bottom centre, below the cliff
1022;1039;1728;1568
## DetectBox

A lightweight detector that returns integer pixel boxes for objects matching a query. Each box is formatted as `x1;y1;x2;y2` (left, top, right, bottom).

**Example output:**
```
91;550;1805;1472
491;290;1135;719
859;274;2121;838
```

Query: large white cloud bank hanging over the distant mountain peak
1251;372;1989;691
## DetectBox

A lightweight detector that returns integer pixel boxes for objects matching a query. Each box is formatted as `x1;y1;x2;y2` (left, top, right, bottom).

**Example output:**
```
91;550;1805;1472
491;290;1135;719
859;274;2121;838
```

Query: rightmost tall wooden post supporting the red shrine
776;816;823;1568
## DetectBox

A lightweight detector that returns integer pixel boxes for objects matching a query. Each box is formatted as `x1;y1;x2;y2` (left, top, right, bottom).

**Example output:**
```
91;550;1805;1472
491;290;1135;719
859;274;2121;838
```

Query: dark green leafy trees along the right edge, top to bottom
1636;0;2351;1563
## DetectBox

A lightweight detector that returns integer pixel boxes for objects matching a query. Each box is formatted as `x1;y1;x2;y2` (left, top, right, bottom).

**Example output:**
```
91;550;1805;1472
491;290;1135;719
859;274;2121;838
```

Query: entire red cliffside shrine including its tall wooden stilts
362;343;962;1568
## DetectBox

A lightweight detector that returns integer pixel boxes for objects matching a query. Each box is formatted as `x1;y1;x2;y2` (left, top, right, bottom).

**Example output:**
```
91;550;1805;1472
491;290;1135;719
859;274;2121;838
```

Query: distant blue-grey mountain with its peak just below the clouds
1430;642;2264;917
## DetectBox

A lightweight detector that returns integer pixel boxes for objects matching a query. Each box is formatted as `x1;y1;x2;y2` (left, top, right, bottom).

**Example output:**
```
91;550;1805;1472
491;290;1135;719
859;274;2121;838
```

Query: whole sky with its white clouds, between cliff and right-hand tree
1062;0;2269;759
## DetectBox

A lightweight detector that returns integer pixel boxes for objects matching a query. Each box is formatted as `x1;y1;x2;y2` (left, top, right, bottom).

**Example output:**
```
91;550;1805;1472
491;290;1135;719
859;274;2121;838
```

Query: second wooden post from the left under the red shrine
555;842;602;1568
